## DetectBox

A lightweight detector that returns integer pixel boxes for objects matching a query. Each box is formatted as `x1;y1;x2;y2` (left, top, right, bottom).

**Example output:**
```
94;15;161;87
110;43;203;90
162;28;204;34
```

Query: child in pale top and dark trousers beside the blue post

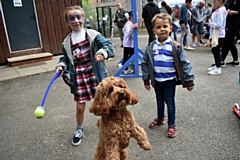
122;11;138;74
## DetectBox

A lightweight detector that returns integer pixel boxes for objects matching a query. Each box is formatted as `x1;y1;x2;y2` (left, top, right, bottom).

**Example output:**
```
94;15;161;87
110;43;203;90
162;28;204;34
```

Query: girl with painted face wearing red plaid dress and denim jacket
56;6;115;146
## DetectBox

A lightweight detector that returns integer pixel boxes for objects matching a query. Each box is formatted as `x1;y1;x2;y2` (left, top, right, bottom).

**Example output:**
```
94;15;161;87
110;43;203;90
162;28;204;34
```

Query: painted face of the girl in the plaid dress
67;9;84;31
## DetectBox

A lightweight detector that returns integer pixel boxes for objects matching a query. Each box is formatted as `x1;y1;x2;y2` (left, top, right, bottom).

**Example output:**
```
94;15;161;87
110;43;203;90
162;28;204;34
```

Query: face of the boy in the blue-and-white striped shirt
153;18;172;42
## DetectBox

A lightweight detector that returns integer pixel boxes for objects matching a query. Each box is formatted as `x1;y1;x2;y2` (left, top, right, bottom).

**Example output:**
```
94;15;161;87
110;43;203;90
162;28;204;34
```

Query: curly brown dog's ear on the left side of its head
89;82;109;116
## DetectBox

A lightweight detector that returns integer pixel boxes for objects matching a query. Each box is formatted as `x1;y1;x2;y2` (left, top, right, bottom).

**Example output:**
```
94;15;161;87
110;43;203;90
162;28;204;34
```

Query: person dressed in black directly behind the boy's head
142;0;160;44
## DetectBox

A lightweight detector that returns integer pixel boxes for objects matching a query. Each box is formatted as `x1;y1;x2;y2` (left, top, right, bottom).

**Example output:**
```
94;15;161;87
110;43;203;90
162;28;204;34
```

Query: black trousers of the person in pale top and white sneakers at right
212;38;224;68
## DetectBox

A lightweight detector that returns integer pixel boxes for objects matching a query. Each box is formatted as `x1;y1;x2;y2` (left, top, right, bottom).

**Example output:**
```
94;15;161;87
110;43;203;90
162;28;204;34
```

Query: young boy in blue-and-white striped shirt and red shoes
141;13;194;138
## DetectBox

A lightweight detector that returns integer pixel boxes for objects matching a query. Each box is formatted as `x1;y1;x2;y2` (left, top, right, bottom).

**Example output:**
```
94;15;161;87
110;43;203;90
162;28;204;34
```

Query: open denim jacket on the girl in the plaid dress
56;28;115;93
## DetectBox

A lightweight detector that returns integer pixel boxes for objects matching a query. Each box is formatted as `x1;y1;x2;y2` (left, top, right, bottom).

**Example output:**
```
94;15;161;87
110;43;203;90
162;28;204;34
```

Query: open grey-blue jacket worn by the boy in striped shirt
141;43;195;87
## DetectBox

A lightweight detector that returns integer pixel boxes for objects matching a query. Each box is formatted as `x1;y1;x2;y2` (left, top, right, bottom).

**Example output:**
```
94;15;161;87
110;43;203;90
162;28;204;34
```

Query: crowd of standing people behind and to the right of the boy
142;0;240;75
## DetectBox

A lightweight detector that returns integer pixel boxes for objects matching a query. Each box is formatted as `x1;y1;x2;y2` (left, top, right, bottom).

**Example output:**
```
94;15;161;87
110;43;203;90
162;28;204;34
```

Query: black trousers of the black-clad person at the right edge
222;31;238;61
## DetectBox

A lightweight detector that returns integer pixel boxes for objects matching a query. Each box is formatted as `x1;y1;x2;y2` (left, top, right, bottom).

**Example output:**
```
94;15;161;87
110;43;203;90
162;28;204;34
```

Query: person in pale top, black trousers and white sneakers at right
208;0;228;75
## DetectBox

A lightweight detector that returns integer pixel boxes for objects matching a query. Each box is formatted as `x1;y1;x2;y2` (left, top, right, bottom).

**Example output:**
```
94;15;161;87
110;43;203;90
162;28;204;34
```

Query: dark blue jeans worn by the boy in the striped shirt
154;79;176;125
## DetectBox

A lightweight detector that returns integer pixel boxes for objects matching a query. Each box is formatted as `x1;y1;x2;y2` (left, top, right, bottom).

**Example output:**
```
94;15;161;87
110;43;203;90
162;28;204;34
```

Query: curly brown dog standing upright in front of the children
89;77;151;160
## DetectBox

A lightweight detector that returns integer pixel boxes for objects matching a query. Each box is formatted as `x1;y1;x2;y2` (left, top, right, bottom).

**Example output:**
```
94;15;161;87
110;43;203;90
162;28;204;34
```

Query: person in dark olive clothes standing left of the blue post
114;2;127;47
